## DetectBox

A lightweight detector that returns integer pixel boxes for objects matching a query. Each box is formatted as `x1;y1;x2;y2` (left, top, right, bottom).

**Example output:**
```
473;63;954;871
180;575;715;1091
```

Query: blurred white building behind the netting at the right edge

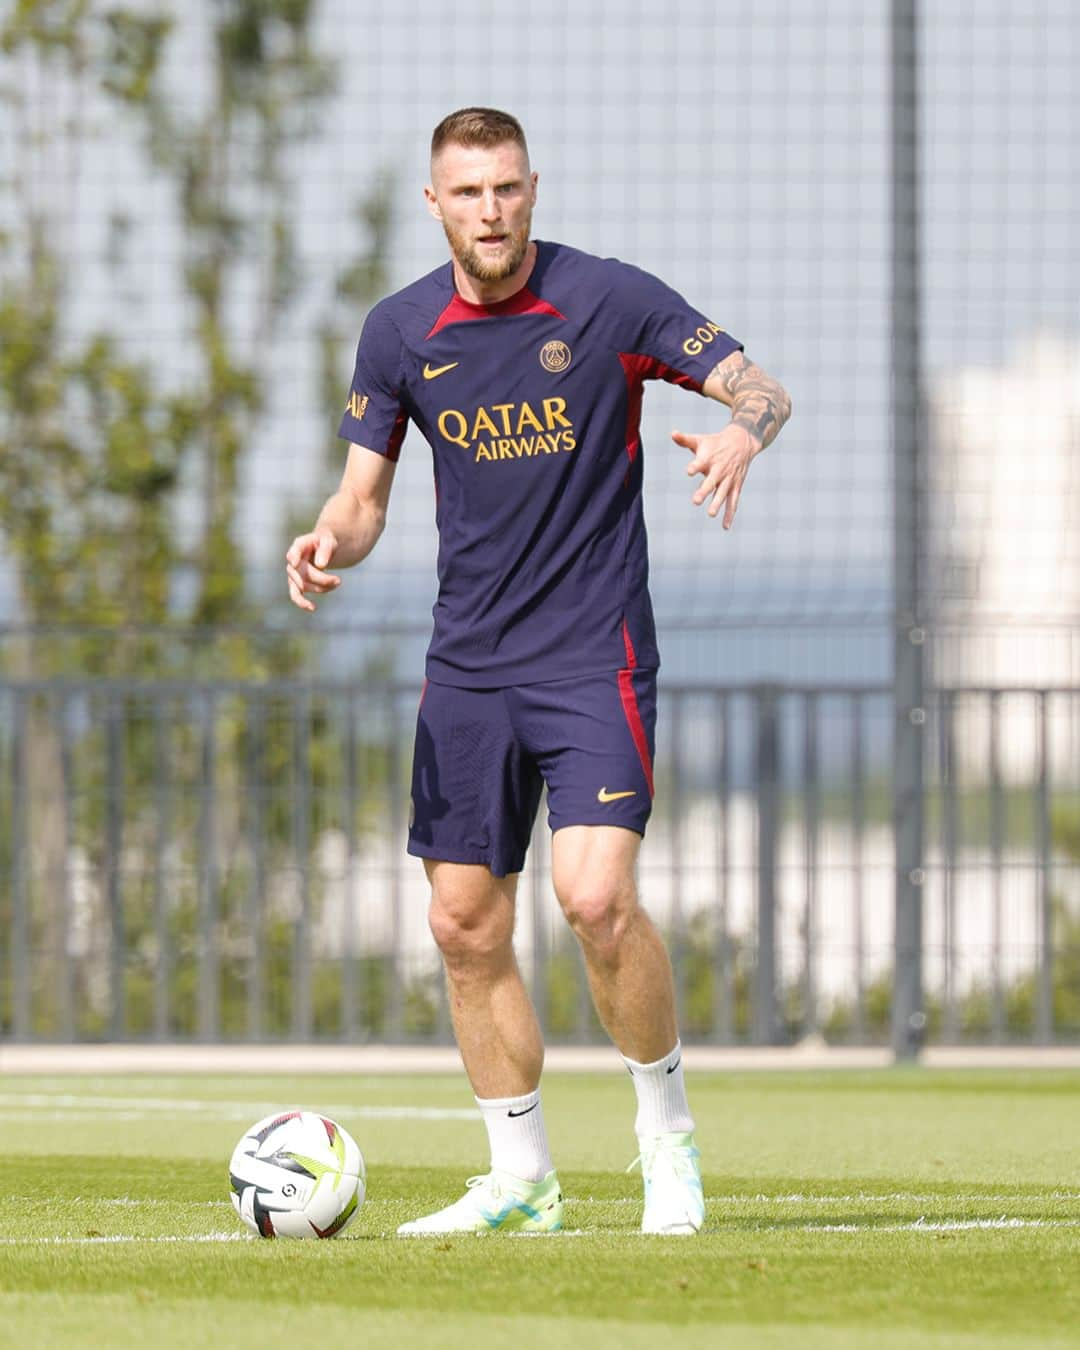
926;333;1080;783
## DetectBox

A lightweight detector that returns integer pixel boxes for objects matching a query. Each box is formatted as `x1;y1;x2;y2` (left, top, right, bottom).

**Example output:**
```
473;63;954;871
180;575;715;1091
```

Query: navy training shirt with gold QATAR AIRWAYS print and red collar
339;240;741;689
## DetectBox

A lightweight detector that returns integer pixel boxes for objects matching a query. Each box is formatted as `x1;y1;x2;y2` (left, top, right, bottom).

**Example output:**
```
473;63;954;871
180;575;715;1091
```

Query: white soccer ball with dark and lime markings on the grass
228;1111;365;1238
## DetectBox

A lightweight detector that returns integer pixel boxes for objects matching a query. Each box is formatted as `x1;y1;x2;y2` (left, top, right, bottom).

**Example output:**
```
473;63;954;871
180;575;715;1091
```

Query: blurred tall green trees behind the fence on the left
0;0;387;1034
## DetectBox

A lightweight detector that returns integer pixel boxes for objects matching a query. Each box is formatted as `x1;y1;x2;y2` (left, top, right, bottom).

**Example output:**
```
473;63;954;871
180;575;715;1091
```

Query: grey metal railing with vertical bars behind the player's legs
0;682;1080;1044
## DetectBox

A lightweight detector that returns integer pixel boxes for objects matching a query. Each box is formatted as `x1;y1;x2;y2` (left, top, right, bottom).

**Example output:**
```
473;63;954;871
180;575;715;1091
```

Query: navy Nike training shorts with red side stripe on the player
409;667;656;876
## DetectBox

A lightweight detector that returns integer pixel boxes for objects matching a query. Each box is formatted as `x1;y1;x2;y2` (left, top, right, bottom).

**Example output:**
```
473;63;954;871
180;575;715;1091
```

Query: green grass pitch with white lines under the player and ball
0;1069;1080;1350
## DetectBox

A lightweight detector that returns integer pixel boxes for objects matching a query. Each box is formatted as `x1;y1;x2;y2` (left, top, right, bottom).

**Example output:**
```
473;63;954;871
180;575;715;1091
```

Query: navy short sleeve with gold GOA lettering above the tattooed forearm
613;263;743;390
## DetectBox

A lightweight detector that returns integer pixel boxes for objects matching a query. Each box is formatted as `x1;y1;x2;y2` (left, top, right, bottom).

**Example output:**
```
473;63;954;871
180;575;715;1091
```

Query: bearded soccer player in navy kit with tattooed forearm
286;108;790;1234
